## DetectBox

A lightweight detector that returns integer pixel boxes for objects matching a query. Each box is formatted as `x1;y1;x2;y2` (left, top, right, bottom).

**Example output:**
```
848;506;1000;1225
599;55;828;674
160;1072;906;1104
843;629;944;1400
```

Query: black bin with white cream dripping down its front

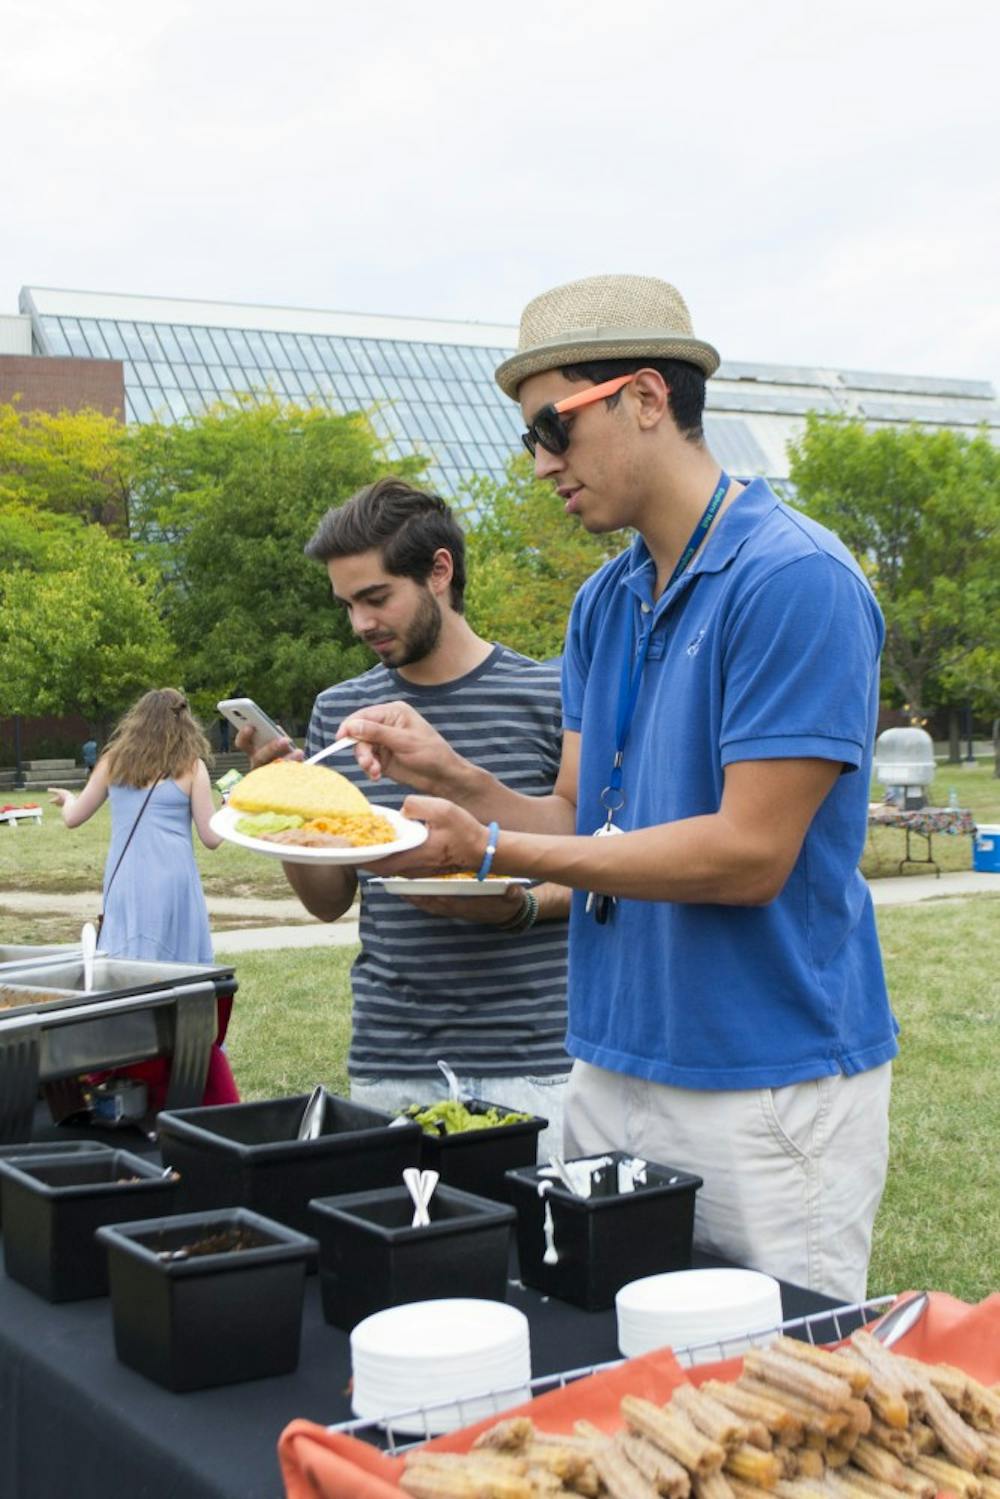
507;1151;702;1312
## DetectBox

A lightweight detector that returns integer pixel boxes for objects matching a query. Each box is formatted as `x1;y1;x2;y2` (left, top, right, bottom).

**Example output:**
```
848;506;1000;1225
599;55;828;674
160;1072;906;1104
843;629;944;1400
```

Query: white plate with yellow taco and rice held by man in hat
211;760;427;863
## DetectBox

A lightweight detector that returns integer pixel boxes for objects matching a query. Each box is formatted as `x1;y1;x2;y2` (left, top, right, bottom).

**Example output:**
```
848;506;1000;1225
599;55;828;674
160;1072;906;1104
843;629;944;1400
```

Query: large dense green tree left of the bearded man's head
130;397;424;727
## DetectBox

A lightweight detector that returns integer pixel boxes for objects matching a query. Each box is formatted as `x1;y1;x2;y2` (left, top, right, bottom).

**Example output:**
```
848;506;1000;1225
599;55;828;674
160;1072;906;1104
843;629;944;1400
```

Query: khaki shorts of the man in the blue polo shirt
565;1061;892;1303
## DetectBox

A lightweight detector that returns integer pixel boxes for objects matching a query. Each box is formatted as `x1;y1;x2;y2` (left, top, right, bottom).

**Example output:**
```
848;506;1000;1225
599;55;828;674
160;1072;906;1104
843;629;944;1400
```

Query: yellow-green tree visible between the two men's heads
457;456;627;661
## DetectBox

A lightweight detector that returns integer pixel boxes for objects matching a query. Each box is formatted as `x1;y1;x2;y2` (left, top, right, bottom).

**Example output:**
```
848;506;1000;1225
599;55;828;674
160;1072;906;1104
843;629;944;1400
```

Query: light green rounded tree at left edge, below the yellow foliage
0;525;174;721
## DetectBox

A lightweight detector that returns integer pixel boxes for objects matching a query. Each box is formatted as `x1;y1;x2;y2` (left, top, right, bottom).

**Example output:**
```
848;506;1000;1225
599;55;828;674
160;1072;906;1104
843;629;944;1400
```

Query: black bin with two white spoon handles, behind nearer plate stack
310;1187;516;1331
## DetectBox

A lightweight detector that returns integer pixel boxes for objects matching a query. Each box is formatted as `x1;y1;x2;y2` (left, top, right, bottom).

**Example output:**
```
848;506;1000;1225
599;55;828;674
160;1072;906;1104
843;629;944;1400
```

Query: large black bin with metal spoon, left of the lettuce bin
157;1094;420;1234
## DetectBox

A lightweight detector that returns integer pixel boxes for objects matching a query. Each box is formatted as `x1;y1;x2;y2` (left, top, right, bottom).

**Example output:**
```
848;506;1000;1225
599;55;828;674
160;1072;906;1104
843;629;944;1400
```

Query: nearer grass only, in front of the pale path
217;895;1000;1301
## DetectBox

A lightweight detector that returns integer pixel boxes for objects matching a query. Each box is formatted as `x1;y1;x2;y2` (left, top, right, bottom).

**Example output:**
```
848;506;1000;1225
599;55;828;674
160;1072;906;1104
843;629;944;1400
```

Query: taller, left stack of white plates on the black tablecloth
351;1297;531;1435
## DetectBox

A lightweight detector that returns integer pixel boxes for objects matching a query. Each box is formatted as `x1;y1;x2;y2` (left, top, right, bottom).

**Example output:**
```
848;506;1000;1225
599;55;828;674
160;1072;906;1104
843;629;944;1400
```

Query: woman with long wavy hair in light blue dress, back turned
49;687;240;1109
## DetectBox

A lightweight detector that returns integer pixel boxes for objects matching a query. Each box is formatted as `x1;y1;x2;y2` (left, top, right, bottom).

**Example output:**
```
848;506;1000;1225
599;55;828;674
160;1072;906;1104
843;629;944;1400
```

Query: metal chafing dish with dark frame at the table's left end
0;947;237;1142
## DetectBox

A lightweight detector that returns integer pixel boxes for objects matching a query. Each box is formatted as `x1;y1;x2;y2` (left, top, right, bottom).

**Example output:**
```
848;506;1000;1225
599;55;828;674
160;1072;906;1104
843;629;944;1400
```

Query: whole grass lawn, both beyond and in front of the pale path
0;761;1000;1300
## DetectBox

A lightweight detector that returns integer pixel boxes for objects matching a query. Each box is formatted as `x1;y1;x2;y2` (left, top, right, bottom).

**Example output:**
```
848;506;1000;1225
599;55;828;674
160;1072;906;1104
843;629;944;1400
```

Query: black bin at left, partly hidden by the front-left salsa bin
0;1150;177;1301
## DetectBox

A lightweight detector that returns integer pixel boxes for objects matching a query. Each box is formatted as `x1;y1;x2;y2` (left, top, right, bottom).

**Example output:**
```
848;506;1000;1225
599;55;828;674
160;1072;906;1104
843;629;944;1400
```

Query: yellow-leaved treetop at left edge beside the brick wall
0;403;129;537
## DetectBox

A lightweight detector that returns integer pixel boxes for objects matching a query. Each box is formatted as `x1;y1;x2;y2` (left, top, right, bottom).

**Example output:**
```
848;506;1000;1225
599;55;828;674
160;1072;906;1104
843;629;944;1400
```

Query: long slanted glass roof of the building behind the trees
13;286;1000;495
